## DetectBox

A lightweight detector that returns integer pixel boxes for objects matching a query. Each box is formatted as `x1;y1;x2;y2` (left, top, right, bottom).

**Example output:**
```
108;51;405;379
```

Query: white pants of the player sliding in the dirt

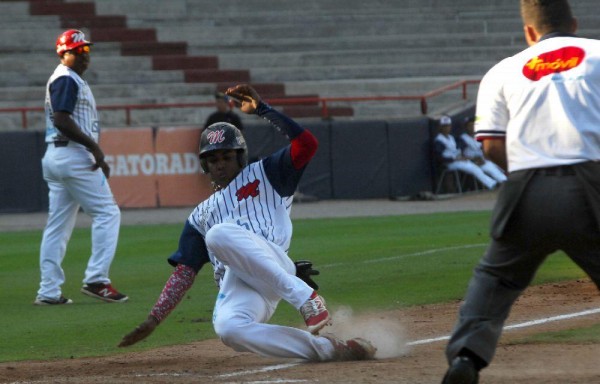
206;223;334;361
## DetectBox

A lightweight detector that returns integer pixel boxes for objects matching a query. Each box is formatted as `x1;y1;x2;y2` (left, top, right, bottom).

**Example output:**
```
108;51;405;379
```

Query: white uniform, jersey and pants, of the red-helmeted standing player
37;64;121;300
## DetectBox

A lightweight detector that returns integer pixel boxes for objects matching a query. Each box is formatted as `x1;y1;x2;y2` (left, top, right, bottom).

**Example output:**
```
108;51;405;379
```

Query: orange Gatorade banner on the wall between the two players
100;128;211;208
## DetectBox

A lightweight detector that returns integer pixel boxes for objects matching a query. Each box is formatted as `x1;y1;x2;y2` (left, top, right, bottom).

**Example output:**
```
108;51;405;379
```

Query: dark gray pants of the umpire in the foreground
446;171;600;364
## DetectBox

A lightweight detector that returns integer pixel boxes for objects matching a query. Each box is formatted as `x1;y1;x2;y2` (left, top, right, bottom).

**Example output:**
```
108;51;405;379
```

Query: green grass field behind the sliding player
0;212;588;362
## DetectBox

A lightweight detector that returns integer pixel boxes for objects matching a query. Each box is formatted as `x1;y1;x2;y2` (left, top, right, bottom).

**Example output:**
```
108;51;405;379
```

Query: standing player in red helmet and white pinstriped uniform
34;29;127;305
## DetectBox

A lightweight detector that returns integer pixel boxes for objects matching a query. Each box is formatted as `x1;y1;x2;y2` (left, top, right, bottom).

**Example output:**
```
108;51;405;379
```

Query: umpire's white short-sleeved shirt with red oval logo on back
475;36;600;172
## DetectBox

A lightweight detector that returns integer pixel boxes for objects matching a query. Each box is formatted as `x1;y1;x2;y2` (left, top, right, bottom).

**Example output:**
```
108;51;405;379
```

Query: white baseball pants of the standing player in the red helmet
37;142;121;299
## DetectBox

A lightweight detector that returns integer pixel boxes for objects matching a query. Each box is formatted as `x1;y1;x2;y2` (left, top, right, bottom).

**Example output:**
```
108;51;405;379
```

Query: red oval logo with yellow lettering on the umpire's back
523;47;585;81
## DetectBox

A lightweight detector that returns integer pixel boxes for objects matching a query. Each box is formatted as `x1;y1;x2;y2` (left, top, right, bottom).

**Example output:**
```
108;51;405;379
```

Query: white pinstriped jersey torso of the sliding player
188;160;293;264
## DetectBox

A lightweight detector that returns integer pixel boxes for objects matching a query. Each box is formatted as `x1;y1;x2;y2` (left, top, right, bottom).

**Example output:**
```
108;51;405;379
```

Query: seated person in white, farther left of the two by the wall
433;116;498;189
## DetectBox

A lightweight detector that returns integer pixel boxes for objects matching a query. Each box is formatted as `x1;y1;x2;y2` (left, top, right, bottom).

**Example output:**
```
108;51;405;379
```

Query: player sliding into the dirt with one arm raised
119;85;375;361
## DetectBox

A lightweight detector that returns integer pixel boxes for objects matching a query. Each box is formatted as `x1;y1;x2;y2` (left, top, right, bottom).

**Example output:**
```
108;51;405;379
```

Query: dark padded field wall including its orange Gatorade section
0;112;474;213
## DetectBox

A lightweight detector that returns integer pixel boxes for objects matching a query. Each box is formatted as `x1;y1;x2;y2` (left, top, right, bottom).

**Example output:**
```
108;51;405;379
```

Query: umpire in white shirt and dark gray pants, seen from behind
443;0;600;384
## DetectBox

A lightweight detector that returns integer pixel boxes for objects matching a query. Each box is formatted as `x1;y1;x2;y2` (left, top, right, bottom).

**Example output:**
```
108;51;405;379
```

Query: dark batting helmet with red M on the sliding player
199;122;248;173
